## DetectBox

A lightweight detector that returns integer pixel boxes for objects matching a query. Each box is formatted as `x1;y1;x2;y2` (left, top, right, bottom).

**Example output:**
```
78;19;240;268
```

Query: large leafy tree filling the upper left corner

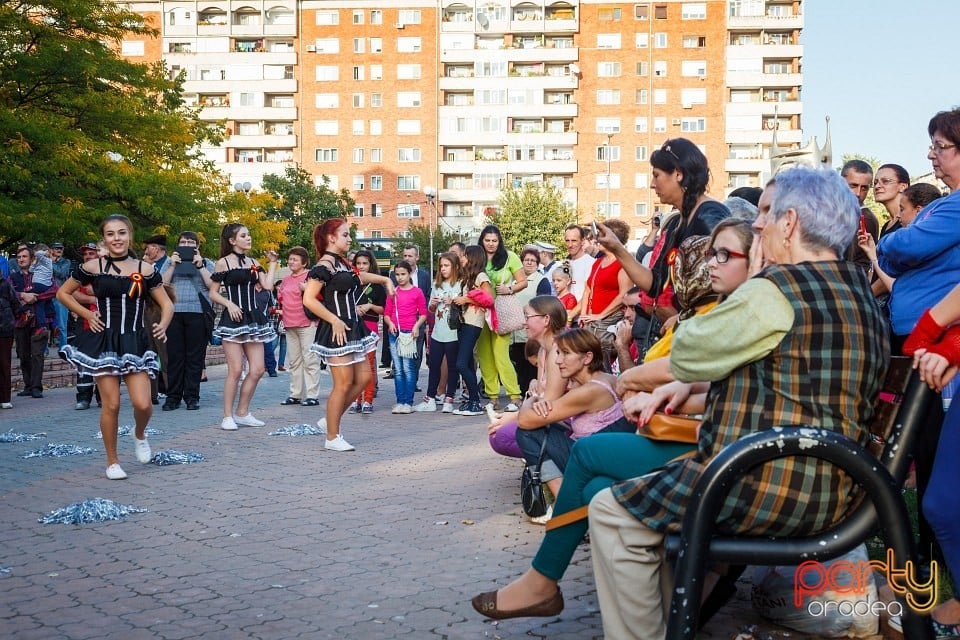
0;0;224;254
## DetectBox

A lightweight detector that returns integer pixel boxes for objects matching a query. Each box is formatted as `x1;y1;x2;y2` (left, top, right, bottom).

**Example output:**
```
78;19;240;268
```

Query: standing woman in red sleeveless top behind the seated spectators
580;219;633;371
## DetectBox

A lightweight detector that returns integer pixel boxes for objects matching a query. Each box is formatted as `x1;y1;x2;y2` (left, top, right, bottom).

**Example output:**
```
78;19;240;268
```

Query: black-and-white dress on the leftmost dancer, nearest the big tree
60;257;163;378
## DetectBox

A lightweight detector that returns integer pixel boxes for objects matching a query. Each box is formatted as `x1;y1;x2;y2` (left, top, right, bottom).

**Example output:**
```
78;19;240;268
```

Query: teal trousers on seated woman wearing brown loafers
533;433;696;580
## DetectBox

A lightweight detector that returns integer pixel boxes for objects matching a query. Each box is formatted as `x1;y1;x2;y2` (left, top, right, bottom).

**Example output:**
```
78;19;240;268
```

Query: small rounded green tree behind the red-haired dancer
263;166;354;252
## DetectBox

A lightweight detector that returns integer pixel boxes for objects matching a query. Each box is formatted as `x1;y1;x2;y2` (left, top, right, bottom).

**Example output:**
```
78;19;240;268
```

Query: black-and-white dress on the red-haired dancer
307;251;379;365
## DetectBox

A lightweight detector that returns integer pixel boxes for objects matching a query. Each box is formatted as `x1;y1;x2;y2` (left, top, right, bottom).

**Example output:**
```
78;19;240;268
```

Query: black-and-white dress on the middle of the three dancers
210;253;277;343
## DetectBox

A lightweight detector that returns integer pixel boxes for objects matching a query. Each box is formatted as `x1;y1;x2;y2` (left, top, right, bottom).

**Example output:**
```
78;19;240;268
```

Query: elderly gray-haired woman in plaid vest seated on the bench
590;168;889;640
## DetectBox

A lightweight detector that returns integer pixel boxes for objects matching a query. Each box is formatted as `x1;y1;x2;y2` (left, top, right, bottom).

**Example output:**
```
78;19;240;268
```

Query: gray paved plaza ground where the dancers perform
0;366;864;640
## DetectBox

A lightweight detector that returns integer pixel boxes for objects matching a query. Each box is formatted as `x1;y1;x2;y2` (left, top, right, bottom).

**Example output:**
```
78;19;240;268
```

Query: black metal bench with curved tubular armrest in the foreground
665;357;939;640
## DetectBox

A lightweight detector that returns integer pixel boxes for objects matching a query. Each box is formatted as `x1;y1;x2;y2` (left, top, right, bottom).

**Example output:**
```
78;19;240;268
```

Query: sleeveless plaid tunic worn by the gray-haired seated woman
613;261;889;535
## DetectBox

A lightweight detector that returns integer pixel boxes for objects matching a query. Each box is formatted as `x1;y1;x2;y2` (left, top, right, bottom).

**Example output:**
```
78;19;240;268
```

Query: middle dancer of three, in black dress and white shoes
210;222;278;431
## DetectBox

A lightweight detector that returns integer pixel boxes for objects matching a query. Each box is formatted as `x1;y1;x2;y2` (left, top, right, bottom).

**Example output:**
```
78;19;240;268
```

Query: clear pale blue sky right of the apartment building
801;0;960;176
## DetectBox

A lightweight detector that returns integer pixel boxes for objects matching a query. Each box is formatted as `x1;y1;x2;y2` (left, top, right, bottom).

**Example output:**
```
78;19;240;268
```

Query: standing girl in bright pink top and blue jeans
383;260;427;413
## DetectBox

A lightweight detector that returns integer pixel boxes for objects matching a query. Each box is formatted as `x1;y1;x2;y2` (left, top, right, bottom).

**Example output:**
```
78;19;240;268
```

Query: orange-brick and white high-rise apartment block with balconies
122;0;803;239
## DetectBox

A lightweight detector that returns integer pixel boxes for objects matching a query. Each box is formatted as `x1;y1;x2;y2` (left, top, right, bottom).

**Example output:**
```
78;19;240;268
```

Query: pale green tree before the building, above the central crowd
488;183;577;254
